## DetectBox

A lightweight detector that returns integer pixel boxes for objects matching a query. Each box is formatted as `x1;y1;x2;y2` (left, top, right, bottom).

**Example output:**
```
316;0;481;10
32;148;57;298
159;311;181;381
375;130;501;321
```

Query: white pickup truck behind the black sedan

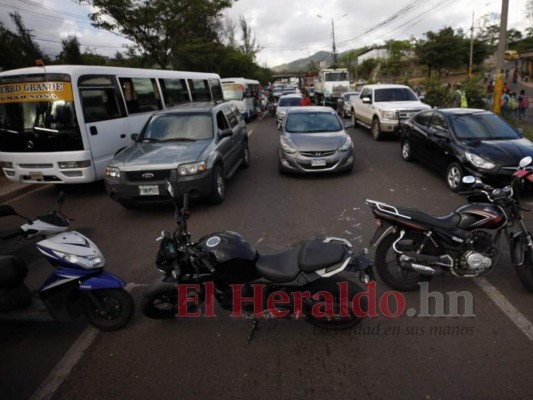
350;84;431;140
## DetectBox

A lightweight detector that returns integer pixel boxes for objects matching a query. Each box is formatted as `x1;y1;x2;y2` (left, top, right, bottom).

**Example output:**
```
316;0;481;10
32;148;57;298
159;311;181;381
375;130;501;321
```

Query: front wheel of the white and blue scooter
85;289;135;331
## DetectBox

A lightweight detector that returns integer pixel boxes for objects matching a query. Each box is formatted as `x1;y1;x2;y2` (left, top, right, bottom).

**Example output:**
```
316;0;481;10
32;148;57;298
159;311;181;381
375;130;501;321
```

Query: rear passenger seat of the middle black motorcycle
298;239;346;272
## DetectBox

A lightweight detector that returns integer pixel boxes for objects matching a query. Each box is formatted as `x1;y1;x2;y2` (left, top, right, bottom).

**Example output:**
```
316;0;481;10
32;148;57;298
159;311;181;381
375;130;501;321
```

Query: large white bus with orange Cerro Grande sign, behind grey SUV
0;65;224;184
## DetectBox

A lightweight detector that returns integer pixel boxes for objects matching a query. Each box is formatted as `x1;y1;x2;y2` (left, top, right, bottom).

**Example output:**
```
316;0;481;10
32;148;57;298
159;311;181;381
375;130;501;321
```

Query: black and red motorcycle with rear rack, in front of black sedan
366;157;533;292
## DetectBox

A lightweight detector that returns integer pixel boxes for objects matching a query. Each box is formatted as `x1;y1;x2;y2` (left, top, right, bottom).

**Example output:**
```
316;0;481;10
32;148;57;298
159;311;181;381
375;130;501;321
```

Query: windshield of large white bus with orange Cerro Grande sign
0;82;83;152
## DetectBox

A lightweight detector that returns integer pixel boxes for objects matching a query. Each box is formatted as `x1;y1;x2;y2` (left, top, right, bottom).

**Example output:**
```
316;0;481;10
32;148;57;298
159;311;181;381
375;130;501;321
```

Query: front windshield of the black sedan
451;114;522;140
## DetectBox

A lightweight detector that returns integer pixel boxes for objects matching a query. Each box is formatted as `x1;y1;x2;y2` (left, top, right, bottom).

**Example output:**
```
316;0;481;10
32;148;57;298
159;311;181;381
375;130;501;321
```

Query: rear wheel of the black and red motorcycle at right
375;233;431;292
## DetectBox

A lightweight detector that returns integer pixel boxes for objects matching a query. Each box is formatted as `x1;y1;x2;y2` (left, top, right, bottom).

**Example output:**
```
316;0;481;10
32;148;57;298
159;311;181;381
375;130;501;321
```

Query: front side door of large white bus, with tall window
79;76;131;179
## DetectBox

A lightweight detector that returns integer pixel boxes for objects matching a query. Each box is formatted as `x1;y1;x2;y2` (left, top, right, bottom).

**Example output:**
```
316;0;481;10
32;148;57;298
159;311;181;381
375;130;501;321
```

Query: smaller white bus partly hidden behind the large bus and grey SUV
221;78;259;121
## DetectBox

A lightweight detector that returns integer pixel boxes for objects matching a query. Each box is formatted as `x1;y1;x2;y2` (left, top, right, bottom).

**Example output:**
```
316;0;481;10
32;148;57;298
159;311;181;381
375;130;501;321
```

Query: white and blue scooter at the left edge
0;193;134;331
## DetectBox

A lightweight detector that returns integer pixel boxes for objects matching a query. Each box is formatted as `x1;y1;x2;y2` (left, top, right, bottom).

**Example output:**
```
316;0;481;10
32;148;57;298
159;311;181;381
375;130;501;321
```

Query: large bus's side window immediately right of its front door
119;78;162;114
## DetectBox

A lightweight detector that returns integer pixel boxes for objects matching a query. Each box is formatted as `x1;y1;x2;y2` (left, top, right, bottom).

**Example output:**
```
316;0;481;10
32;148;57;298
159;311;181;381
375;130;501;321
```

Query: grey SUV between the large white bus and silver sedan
105;102;250;207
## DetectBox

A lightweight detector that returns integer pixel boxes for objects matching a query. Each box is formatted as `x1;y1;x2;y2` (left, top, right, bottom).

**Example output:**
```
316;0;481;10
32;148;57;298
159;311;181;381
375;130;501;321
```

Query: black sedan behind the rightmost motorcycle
401;108;533;192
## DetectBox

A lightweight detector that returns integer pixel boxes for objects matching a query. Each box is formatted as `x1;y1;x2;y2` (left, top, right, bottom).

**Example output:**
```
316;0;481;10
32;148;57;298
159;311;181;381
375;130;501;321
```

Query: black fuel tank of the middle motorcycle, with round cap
198;231;258;282
